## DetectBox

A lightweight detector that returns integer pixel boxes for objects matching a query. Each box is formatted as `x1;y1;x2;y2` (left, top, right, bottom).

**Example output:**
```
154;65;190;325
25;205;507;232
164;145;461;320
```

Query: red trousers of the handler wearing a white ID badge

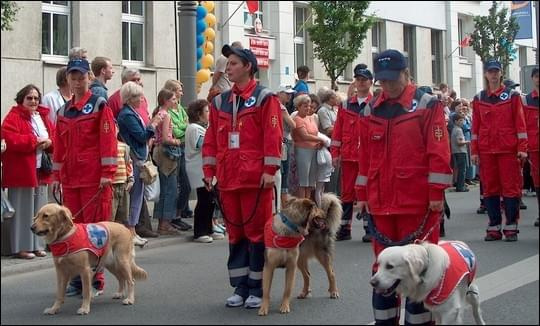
219;188;274;244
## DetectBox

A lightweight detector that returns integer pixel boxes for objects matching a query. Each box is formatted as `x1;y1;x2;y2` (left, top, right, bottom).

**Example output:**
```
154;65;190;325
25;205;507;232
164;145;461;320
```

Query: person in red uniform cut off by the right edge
521;68;540;226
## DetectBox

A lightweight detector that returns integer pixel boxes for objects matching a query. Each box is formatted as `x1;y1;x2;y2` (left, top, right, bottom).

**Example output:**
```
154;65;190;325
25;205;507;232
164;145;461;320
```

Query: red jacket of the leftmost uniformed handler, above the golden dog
53;91;117;188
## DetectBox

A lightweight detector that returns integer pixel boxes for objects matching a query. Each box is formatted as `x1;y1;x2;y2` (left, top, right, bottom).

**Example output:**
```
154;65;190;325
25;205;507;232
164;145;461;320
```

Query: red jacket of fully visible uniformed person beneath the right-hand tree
471;86;527;155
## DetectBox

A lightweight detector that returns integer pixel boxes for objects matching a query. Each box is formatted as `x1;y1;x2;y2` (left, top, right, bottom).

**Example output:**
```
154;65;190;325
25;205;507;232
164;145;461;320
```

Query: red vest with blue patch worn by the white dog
424;241;476;305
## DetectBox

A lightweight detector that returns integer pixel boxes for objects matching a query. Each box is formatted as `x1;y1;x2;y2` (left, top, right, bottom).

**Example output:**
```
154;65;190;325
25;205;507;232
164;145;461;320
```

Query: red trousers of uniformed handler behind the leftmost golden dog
63;186;112;223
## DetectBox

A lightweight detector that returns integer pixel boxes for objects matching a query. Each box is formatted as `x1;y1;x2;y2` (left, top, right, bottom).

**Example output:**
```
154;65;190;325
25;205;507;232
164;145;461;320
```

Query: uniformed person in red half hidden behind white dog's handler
330;64;373;242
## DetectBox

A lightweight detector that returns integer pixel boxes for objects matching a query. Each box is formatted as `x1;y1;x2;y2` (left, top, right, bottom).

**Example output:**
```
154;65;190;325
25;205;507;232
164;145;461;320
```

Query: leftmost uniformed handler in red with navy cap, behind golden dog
53;59;117;295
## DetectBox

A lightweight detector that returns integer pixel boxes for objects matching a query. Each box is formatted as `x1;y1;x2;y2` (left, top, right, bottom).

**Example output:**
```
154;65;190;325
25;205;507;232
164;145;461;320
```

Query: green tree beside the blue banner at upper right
471;1;519;71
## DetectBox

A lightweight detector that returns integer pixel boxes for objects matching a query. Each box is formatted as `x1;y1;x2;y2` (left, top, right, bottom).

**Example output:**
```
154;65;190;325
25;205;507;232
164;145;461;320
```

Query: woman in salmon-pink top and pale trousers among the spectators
292;94;321;198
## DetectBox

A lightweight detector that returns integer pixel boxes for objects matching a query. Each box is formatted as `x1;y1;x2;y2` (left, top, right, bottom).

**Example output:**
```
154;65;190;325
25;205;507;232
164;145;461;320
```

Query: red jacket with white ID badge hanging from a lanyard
202;80;282;190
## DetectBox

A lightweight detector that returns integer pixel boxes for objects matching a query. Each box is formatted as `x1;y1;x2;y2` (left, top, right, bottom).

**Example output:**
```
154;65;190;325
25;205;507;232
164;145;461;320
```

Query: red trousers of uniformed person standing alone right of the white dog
480;153;523;198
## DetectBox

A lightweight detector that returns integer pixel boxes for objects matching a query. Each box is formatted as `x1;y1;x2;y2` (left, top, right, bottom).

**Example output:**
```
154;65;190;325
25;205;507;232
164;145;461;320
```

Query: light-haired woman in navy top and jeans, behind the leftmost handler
118;81;161;246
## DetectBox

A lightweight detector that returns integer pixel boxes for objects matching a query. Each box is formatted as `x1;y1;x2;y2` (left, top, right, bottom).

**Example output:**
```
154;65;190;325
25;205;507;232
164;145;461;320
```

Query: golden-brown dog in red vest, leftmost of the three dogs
32;204;148;315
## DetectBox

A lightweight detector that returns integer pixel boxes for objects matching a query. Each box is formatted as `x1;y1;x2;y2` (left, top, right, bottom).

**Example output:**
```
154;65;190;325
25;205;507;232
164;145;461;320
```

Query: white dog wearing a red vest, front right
370;241;485;325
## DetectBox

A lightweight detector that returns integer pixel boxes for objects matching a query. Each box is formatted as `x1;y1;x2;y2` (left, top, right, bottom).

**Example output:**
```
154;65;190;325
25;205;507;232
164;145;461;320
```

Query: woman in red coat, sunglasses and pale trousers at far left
2;84;54;259
